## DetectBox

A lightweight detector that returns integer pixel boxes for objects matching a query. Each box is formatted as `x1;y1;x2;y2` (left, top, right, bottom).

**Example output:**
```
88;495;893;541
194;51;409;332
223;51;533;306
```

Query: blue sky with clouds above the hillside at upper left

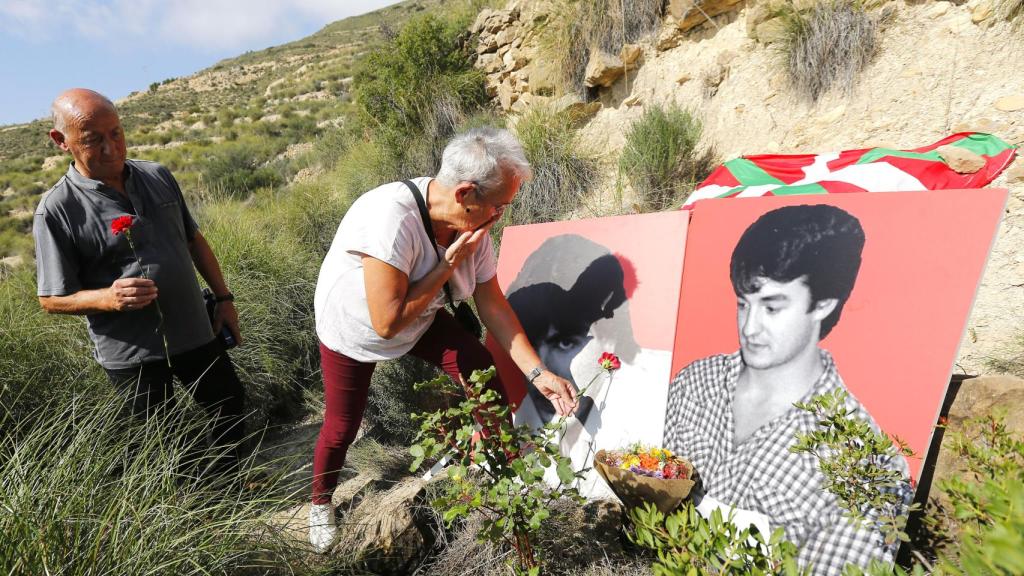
0;0;396;125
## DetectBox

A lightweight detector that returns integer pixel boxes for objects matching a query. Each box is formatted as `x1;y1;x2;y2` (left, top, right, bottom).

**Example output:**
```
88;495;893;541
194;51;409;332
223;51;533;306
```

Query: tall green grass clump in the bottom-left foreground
0;387;301;576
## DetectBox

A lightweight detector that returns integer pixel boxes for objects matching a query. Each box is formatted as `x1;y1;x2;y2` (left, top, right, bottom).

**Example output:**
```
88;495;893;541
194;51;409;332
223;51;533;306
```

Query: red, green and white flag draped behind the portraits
683;132;1016;208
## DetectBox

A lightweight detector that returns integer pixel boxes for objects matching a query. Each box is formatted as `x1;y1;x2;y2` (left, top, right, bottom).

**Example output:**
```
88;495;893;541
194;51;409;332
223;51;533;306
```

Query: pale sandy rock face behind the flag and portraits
474;0;1024;373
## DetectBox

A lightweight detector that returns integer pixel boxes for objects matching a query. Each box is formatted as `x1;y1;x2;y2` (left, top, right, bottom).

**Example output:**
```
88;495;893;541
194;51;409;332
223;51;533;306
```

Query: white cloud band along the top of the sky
0;0;395;50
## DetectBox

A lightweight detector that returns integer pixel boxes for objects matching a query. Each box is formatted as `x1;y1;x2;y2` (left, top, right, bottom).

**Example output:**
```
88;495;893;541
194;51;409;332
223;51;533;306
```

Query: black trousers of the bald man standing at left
105;339;245;472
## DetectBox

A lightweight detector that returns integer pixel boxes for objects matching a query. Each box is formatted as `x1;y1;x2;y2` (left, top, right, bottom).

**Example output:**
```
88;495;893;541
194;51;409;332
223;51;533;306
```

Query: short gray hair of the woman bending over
437;126;534;196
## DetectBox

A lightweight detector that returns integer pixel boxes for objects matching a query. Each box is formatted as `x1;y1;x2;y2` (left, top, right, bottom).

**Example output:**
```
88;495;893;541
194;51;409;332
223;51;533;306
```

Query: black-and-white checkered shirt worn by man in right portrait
664;351;912;576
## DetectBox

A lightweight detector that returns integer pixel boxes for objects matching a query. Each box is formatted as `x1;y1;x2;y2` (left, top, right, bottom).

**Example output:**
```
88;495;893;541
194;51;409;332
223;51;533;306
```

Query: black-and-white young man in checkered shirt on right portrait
665;204;911;574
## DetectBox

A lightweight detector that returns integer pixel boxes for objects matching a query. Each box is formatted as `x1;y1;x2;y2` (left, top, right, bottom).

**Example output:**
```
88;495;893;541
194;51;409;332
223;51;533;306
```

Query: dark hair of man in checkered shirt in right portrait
729;204;864;338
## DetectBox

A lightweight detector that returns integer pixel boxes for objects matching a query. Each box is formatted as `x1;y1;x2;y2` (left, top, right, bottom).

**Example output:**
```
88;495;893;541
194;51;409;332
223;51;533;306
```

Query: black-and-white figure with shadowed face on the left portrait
506;234;671;493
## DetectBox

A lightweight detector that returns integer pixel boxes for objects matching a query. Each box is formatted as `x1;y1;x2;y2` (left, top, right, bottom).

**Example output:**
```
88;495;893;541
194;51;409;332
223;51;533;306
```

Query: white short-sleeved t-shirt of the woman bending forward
313;177;497;362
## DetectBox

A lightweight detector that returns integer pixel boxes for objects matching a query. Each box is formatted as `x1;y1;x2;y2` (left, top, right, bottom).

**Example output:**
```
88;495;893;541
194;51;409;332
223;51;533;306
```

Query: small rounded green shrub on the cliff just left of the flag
618;106;714;211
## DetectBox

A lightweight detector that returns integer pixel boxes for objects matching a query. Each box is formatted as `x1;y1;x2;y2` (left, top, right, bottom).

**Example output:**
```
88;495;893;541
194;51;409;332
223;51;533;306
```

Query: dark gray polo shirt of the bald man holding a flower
32;160;213;369
